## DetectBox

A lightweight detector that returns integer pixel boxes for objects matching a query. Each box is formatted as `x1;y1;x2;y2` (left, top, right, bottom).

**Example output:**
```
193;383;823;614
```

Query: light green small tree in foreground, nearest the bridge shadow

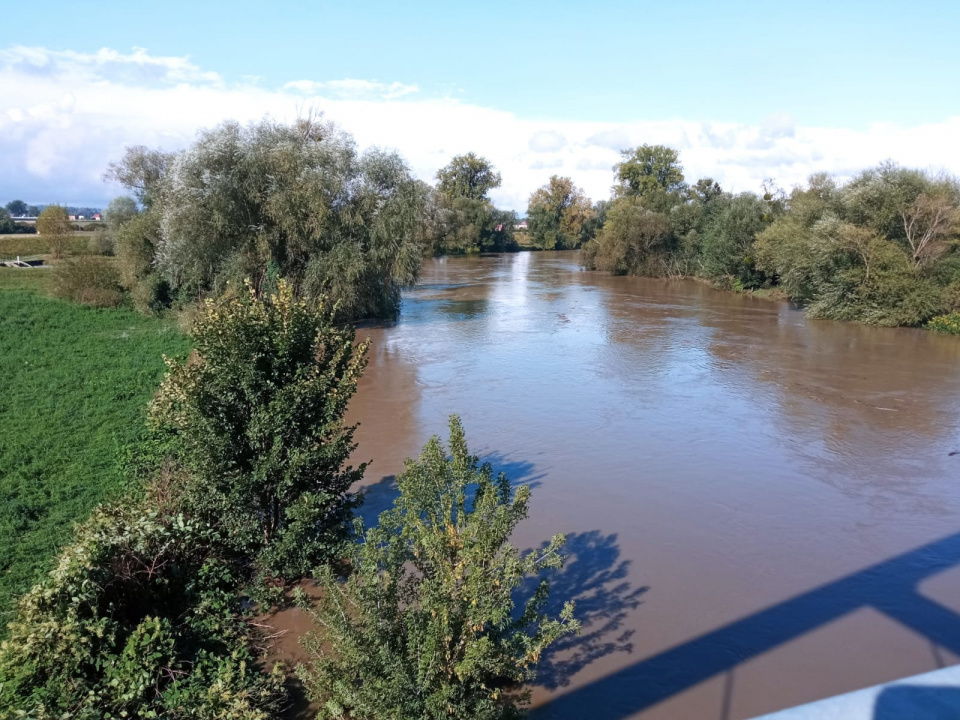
299;417;579;720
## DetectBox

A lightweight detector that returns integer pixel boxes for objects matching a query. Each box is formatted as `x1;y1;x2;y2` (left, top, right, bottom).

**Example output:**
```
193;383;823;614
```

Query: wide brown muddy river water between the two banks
351;253;960;720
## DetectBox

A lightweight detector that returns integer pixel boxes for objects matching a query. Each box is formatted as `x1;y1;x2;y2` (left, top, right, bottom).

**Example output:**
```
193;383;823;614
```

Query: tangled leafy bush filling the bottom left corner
0;500;282;720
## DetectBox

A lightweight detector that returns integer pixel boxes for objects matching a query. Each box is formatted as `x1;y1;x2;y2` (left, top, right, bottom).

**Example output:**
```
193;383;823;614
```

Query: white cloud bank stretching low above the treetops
0;46;960;213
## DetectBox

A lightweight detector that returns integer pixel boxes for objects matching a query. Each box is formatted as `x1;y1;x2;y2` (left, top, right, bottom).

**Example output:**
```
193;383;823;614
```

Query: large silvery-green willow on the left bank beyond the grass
104;119;426;318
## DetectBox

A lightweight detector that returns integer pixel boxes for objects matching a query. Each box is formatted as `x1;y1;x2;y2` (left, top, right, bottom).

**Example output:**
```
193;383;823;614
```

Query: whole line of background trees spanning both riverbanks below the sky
30;118;960;332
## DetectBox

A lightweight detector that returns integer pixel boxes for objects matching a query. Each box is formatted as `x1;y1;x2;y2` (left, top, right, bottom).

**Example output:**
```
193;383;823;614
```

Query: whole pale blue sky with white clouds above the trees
0;0;960;206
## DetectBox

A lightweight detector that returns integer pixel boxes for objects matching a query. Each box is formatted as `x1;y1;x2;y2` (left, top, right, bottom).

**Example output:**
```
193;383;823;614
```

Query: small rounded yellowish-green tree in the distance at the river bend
527;175;594;250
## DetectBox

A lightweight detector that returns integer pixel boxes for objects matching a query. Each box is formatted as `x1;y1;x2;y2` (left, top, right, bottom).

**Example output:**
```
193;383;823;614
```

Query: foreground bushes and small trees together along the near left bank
0;280;577;720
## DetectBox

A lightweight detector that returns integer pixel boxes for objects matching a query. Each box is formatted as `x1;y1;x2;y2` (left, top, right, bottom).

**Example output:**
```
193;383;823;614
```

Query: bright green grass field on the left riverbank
0;278;189;616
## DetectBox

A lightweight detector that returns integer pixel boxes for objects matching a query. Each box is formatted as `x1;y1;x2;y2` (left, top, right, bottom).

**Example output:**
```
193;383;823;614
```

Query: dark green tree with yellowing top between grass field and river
150;281;367;579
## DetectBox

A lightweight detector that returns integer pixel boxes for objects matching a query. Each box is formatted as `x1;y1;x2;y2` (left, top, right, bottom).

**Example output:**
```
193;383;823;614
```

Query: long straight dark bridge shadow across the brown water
532;533;960;720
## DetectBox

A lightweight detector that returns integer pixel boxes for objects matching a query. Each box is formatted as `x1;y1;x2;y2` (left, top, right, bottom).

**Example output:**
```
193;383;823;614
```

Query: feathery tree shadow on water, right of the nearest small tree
517;530;647;690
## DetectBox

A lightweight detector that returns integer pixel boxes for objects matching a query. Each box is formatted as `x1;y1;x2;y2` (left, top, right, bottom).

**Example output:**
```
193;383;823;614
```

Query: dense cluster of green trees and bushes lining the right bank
582;145;960;325
